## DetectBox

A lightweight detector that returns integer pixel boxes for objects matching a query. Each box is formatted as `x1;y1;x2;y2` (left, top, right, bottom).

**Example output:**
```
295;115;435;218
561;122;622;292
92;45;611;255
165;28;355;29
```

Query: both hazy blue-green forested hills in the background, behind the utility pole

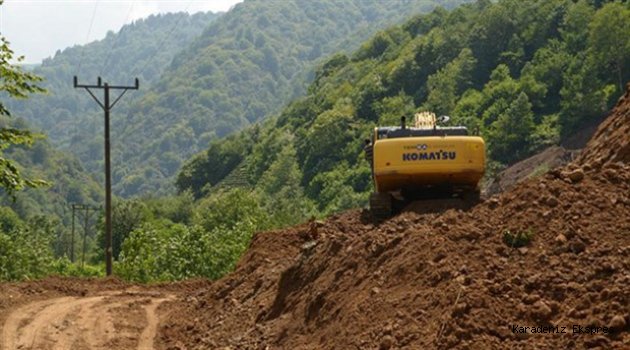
8;0;474;197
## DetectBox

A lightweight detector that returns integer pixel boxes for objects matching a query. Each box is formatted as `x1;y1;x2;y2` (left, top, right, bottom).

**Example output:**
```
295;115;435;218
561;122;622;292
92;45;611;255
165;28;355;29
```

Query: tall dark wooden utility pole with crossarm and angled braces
74;75;140;276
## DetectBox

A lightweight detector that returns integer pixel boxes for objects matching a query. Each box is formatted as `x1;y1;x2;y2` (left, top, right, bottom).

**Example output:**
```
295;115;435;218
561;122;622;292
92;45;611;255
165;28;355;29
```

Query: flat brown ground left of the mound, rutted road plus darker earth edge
0;277;205;350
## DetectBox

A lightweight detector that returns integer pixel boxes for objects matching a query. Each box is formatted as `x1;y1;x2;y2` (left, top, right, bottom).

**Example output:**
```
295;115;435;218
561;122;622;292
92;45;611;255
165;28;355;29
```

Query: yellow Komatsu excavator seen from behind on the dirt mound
364;112;486;221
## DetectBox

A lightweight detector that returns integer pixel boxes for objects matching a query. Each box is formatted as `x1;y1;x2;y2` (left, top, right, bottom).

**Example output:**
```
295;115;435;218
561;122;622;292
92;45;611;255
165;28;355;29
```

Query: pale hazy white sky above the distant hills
0;0;242;63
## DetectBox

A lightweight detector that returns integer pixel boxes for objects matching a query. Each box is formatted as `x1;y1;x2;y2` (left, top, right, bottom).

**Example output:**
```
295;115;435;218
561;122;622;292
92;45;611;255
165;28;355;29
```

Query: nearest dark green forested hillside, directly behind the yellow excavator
177;0;630;214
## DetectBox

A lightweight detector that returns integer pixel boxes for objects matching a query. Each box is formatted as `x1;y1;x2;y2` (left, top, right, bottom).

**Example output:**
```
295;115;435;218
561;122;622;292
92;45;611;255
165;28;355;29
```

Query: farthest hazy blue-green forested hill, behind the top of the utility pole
9;13;218;146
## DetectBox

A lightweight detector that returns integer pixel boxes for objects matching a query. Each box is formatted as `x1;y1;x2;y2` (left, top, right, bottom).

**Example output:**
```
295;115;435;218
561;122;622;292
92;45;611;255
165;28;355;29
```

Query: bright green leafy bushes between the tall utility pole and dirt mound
117;189;270;282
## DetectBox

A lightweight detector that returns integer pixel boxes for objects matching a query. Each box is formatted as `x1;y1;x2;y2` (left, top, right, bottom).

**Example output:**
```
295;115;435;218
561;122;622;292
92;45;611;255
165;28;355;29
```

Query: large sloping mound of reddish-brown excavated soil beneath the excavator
159;86;630;349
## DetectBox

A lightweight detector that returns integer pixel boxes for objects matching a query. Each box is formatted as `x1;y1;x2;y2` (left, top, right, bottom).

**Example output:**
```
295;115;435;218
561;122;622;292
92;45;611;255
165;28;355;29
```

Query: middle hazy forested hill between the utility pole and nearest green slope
94;0;470;196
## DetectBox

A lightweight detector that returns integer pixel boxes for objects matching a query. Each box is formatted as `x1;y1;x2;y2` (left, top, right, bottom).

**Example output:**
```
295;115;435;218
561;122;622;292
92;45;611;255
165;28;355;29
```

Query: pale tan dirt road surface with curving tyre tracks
0;288;175;350
